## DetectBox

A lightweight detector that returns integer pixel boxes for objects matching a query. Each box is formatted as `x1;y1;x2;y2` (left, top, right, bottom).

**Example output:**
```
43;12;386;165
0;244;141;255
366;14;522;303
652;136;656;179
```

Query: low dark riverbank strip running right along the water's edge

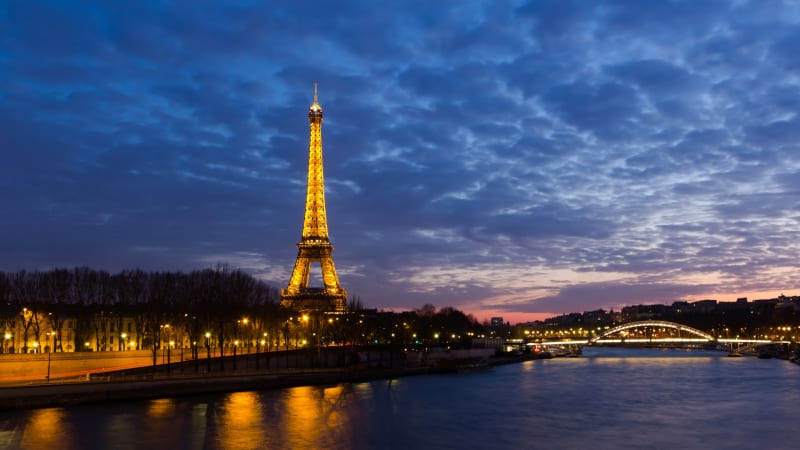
0;355;533;409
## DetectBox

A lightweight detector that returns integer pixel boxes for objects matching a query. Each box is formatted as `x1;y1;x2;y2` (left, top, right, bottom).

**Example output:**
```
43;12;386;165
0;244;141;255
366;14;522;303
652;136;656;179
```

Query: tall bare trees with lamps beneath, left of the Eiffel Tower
0;266;291;351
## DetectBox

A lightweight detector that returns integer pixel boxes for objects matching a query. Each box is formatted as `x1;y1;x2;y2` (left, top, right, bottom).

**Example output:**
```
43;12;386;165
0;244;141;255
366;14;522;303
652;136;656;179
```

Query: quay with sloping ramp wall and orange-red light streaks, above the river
0;351;536;410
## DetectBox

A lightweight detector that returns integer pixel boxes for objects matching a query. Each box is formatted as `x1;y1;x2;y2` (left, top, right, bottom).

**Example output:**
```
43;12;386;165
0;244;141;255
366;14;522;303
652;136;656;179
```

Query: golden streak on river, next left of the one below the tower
217;392;266;448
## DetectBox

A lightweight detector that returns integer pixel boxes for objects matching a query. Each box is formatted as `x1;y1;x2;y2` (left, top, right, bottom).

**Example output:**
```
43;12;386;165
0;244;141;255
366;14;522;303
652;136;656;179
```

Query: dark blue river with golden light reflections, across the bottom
0;348;800;450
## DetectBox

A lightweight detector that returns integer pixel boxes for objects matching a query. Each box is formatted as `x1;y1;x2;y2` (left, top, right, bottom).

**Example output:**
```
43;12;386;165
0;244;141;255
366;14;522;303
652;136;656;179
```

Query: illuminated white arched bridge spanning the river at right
539;320;789;349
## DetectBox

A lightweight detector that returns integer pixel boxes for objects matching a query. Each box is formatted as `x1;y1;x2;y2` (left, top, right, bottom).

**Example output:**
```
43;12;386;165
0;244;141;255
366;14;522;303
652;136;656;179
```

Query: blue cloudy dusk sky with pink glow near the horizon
0;0;800;322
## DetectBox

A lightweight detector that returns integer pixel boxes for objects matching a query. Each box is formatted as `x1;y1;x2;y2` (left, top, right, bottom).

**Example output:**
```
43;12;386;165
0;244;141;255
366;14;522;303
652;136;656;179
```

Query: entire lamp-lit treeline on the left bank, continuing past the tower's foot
0;266;487;358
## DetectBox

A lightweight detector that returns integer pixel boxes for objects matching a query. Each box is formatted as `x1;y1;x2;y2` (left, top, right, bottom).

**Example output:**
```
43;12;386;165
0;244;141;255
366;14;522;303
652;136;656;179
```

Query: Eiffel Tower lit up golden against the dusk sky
281;83;347;312
